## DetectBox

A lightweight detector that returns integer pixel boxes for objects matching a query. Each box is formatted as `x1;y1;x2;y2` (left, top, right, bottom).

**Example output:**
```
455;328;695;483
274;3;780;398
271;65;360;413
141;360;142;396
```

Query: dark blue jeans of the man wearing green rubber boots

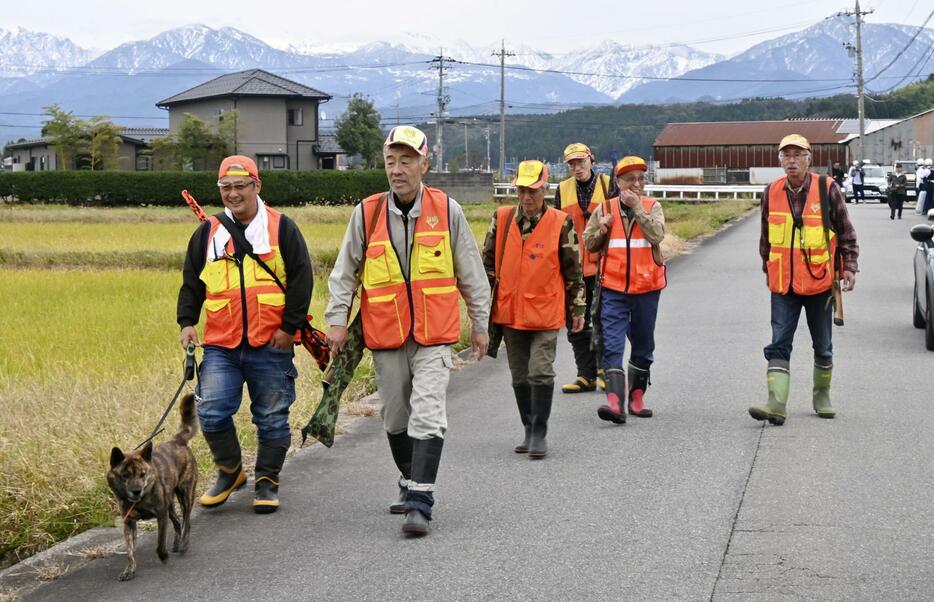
764;291;833;366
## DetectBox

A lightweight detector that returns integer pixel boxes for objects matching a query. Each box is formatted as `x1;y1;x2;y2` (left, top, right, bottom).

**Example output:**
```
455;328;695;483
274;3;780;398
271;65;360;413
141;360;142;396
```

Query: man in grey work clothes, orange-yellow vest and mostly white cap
325;126;490;536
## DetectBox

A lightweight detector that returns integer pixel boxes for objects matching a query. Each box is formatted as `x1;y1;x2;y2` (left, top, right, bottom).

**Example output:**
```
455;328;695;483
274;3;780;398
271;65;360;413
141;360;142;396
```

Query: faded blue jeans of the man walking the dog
196;345;298;439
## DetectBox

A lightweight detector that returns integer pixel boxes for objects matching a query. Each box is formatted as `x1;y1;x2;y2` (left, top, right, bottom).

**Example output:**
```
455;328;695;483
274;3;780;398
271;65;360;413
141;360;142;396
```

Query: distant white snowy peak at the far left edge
0;27;101;77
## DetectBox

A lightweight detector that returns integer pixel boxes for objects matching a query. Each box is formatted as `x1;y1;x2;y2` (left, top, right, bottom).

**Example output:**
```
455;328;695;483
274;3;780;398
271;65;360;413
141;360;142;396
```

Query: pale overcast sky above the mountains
0;0;931;54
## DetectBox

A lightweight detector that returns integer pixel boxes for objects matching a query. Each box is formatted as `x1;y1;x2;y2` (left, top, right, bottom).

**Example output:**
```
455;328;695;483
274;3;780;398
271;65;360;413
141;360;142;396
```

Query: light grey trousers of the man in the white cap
373;337;454;439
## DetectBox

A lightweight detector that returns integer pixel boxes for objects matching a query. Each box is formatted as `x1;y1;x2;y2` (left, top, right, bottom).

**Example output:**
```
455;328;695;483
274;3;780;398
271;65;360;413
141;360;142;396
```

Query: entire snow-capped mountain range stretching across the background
0;17;934;139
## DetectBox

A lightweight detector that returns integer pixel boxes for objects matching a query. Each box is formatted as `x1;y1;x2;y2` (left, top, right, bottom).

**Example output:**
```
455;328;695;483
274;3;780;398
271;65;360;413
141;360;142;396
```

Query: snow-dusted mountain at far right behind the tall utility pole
620;17;934;103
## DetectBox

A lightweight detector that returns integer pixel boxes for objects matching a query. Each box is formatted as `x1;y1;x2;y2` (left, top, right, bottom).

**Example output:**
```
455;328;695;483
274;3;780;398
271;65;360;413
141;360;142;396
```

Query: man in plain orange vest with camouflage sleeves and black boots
483;161;585;459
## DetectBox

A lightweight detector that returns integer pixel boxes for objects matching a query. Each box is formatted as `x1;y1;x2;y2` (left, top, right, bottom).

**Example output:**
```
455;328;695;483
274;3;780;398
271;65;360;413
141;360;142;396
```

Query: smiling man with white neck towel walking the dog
177;155;312;514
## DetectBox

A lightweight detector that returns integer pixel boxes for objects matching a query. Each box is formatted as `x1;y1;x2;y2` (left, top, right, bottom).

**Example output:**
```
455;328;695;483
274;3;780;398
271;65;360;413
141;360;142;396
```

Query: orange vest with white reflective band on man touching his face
602;196;668;295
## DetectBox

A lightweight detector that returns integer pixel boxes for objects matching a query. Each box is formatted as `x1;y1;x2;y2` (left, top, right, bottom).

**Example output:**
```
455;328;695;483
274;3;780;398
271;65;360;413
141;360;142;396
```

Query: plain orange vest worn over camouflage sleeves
492;207;567;330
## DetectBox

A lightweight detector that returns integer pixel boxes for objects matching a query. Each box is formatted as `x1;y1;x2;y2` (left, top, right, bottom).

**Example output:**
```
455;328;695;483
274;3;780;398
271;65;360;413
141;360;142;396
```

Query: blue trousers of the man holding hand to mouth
600;288;662;369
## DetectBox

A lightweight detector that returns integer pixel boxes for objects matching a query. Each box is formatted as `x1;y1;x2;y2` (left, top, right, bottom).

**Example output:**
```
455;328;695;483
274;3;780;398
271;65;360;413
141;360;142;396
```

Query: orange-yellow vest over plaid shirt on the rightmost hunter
767;173;837;295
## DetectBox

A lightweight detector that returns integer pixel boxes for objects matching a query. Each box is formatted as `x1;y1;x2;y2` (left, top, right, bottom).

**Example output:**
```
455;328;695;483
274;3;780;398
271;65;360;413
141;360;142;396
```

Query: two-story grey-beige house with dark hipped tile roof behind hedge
156;69;346;170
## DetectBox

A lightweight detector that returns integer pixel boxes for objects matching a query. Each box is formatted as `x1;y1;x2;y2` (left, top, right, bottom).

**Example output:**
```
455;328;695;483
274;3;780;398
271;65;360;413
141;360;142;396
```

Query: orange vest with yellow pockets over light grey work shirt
360;186;460;349
